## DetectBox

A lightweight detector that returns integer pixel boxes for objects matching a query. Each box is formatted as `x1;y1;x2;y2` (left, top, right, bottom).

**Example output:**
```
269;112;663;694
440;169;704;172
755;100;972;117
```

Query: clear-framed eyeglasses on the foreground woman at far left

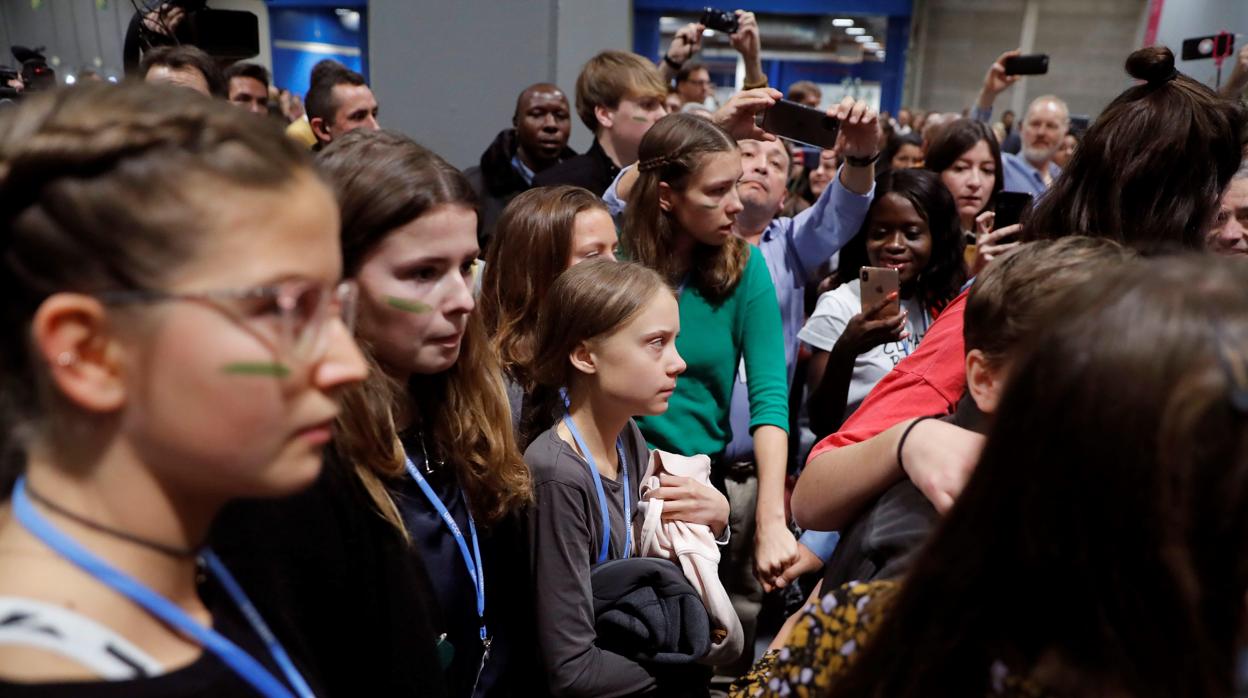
95;281;359;363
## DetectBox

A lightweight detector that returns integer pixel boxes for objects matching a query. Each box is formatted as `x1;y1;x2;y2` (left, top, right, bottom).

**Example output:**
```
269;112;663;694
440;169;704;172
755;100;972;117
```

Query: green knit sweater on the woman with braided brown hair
636;247;789;458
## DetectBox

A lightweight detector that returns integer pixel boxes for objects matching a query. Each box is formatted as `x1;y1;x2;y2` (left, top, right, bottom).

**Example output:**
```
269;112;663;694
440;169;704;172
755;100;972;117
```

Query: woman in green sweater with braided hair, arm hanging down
623;114;797;584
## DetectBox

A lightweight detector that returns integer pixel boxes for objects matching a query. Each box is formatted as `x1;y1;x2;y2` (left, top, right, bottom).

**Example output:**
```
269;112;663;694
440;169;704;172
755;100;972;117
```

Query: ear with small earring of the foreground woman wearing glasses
31;293;126;413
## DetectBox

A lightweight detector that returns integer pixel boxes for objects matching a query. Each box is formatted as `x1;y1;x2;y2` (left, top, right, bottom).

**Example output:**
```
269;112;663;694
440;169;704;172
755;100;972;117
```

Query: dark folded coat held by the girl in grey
590;557;710;664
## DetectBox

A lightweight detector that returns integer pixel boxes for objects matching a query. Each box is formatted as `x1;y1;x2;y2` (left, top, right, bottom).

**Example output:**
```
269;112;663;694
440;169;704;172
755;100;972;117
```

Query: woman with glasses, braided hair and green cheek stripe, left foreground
0;85;366;698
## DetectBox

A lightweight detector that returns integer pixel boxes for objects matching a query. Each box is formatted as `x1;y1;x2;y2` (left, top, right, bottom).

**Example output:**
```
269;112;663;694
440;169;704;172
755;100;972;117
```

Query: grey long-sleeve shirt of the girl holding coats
524;422;655;698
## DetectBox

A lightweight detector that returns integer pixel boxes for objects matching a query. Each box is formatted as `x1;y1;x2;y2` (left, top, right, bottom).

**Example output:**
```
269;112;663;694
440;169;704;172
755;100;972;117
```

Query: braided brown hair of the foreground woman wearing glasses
0;84;311;487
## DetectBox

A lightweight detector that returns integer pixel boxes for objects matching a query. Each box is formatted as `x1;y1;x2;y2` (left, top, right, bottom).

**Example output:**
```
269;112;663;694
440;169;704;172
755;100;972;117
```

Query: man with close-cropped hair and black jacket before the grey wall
464;82;577;250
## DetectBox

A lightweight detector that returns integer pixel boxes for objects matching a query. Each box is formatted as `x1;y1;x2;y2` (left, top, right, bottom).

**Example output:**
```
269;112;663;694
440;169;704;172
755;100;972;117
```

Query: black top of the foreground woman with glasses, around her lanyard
0;576;312;698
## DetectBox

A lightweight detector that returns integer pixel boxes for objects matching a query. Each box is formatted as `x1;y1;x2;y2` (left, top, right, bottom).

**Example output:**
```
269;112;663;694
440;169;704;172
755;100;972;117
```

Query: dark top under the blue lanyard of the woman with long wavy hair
387;436;538;698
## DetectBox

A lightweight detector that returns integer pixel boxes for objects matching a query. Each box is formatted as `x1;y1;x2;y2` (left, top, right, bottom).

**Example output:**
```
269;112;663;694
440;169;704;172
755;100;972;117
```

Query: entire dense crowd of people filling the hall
0;10;1248;698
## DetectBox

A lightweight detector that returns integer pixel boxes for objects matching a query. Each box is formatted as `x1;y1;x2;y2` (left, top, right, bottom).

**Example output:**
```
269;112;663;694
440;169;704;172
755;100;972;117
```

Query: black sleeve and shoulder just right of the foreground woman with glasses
212;450;447;698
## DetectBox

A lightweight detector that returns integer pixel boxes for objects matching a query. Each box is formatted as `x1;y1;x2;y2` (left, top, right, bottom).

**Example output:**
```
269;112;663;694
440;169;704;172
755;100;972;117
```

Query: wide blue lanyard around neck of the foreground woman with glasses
12;477;313;698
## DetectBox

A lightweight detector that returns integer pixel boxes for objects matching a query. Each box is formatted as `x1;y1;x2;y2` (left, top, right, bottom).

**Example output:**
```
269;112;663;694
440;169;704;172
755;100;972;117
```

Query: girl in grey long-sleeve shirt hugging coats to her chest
524;261;728;697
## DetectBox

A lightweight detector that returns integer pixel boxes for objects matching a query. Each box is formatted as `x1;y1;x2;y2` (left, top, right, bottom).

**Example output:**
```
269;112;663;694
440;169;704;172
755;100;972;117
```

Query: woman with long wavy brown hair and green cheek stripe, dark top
318;130;532;696
